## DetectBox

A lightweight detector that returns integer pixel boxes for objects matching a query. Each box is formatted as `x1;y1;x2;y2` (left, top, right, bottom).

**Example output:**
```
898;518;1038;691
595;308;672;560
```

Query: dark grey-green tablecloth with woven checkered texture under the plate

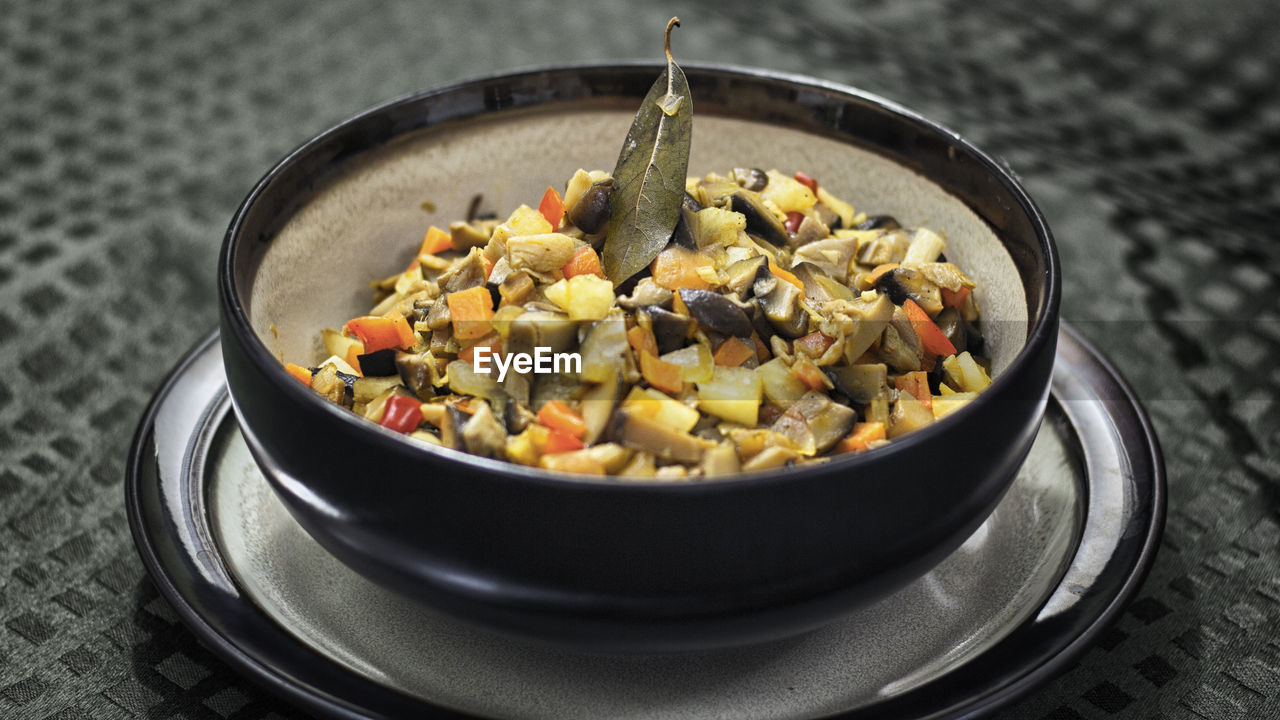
0;0;1280;720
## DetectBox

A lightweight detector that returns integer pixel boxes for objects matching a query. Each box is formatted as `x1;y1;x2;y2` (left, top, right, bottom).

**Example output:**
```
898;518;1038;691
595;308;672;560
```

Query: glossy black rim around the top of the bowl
218;60;1061;495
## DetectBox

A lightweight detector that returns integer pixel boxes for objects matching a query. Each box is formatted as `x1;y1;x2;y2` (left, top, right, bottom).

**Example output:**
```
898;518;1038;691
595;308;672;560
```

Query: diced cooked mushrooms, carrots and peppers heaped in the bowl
287;168;991;479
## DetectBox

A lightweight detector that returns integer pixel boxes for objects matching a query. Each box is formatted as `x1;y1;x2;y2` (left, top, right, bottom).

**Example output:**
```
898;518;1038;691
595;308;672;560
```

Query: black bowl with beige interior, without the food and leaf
219;64;1060;651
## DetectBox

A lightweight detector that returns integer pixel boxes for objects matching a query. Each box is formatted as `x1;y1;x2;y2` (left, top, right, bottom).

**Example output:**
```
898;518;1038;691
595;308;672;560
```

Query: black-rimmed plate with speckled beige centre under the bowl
125;327;1165;717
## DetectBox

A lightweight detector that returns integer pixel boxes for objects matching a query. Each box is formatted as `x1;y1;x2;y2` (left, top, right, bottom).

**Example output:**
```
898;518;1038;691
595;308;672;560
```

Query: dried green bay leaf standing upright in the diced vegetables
600;18;694;287
